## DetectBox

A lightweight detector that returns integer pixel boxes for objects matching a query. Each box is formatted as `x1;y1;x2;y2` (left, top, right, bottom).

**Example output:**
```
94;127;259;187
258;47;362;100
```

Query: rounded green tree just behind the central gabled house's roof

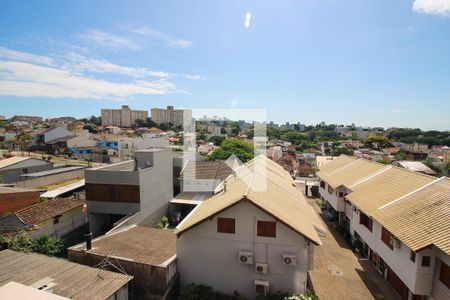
208;139;254;162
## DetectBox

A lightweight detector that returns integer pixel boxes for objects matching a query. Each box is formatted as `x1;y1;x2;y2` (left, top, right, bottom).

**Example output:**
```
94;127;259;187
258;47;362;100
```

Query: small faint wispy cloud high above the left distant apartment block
78;29;141;50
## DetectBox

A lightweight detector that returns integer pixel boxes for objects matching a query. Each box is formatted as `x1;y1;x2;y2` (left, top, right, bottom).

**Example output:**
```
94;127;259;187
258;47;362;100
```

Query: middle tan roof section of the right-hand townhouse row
346;167;436;216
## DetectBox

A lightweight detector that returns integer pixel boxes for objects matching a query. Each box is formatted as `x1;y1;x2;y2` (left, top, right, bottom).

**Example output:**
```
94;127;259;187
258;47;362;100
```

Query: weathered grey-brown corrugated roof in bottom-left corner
0;250;133;300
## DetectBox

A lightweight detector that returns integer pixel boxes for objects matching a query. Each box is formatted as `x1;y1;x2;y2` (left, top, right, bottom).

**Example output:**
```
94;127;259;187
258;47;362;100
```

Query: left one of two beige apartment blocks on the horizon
102;105;148;127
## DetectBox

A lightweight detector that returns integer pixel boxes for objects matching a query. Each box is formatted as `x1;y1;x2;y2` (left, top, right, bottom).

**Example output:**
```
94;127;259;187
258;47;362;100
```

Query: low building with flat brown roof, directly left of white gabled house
67;225;178;299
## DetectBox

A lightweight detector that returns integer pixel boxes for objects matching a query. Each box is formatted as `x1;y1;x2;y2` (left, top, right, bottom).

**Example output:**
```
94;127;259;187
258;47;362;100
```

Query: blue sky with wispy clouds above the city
0;0;450;130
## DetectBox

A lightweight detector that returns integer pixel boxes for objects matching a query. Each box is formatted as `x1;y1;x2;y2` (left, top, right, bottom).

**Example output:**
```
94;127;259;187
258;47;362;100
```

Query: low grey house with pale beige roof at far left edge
0;156;53;183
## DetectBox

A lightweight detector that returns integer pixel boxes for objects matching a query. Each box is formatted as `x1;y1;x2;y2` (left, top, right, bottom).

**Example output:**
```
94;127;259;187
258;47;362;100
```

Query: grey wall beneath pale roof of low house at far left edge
0;158;53;183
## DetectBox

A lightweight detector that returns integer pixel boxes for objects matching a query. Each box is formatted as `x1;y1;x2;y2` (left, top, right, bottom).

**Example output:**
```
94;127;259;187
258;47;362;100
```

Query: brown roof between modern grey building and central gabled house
180;160;233;180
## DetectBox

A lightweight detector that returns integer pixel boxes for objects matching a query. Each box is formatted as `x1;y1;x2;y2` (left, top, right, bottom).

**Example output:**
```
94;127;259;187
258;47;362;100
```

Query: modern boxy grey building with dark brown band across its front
85;149;173;236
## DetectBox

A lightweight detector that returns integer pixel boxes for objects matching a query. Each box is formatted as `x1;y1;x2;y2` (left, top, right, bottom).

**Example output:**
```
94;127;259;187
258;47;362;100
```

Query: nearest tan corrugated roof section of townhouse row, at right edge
372;178;450;255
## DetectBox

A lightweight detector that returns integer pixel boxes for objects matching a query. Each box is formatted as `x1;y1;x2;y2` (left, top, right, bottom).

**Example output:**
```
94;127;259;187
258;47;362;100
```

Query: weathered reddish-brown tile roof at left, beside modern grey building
15;198;86;226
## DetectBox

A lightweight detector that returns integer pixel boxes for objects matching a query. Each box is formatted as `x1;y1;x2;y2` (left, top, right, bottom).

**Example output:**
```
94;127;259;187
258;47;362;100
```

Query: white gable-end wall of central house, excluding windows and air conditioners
177;202;312;297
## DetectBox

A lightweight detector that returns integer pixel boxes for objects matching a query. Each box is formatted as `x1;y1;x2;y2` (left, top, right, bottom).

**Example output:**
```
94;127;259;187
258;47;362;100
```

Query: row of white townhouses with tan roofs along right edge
318;156;450;299
